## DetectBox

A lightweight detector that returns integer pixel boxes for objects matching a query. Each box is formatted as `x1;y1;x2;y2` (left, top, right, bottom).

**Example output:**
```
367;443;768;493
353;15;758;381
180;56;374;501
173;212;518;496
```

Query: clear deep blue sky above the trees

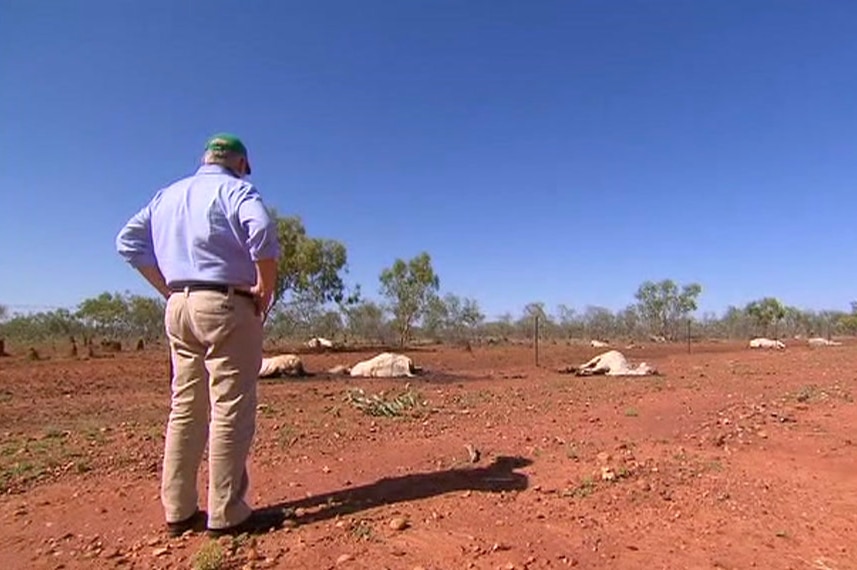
0;0;857;316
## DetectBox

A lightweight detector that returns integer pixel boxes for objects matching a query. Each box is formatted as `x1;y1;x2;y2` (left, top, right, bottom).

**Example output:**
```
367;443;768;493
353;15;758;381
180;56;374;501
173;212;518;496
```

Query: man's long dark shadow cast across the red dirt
266;456;533;524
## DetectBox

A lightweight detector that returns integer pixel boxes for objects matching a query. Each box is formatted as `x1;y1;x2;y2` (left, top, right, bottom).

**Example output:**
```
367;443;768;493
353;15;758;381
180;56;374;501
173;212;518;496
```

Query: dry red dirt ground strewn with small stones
0;342;857;570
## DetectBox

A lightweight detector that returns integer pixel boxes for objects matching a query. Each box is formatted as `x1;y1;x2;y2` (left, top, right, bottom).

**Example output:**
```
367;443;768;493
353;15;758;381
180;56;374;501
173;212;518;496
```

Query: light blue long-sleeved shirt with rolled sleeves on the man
116;164;280;287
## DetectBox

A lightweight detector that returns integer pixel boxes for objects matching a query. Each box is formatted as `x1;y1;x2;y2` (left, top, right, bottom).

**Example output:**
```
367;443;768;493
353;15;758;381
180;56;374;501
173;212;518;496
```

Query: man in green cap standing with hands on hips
116;133;283;536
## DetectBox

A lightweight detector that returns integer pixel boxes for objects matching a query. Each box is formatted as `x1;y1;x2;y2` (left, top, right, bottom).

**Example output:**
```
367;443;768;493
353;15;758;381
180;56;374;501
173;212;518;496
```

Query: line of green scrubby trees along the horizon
0;212;857;345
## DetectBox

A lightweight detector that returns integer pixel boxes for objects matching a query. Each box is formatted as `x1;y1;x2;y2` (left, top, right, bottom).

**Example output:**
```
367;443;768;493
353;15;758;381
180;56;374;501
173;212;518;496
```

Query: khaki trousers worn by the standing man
161;291;262;528
